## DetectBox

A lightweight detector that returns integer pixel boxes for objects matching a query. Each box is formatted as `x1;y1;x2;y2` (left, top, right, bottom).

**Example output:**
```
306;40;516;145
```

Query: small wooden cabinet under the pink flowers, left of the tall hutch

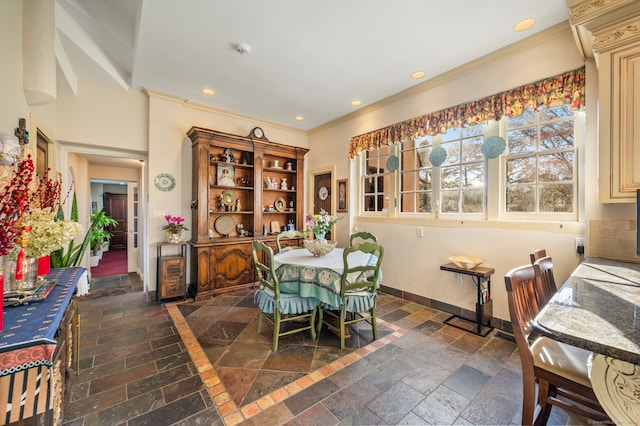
156;242;187;300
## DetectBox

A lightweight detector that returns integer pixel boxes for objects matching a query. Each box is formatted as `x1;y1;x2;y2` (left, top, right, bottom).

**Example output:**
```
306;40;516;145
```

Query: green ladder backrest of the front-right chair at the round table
340;242;384;296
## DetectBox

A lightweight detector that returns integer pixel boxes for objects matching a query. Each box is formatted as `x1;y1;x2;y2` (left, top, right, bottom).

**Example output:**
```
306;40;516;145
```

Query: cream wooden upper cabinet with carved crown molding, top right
567;0;640;203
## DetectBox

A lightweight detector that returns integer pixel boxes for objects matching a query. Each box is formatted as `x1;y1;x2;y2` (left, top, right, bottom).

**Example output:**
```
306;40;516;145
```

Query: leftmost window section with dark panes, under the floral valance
362;145;394;212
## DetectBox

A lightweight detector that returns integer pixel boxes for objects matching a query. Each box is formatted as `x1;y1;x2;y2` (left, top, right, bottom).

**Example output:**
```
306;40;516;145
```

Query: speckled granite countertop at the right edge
533;258;640;365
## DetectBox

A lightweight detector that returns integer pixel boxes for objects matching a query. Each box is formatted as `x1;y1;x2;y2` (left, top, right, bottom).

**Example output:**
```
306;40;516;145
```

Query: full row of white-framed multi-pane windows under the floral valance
360;105;583;220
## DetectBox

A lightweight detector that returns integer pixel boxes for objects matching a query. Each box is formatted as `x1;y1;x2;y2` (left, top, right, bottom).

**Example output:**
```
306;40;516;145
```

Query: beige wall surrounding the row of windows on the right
309;24;635;320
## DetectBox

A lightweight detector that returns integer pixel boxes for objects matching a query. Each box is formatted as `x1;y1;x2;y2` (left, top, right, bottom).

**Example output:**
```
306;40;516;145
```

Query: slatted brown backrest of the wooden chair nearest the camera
504;265;540;372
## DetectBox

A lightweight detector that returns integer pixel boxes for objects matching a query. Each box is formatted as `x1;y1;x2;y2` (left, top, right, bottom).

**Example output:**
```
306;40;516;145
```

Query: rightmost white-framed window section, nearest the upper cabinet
504;105;576;214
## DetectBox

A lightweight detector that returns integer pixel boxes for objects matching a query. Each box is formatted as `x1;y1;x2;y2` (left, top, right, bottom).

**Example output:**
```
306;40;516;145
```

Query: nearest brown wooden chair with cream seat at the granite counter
504;265;609;425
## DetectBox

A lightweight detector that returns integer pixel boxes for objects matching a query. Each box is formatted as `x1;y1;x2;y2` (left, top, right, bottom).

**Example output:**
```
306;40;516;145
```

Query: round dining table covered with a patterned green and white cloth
274;248;379;309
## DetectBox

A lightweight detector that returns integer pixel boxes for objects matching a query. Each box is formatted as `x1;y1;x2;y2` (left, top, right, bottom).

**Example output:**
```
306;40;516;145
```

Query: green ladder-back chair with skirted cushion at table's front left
253;241;319;352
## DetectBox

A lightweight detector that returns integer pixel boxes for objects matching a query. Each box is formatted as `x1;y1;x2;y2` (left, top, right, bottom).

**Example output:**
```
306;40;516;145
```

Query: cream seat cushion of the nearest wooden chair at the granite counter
531;337;591;388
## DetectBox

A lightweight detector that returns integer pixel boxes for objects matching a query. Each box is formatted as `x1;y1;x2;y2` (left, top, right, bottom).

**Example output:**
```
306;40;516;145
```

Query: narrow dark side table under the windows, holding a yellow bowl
440;262;495;337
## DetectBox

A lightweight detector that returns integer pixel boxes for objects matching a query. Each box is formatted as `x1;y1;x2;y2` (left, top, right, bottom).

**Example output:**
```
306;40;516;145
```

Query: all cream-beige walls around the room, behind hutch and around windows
0;0;635;319
